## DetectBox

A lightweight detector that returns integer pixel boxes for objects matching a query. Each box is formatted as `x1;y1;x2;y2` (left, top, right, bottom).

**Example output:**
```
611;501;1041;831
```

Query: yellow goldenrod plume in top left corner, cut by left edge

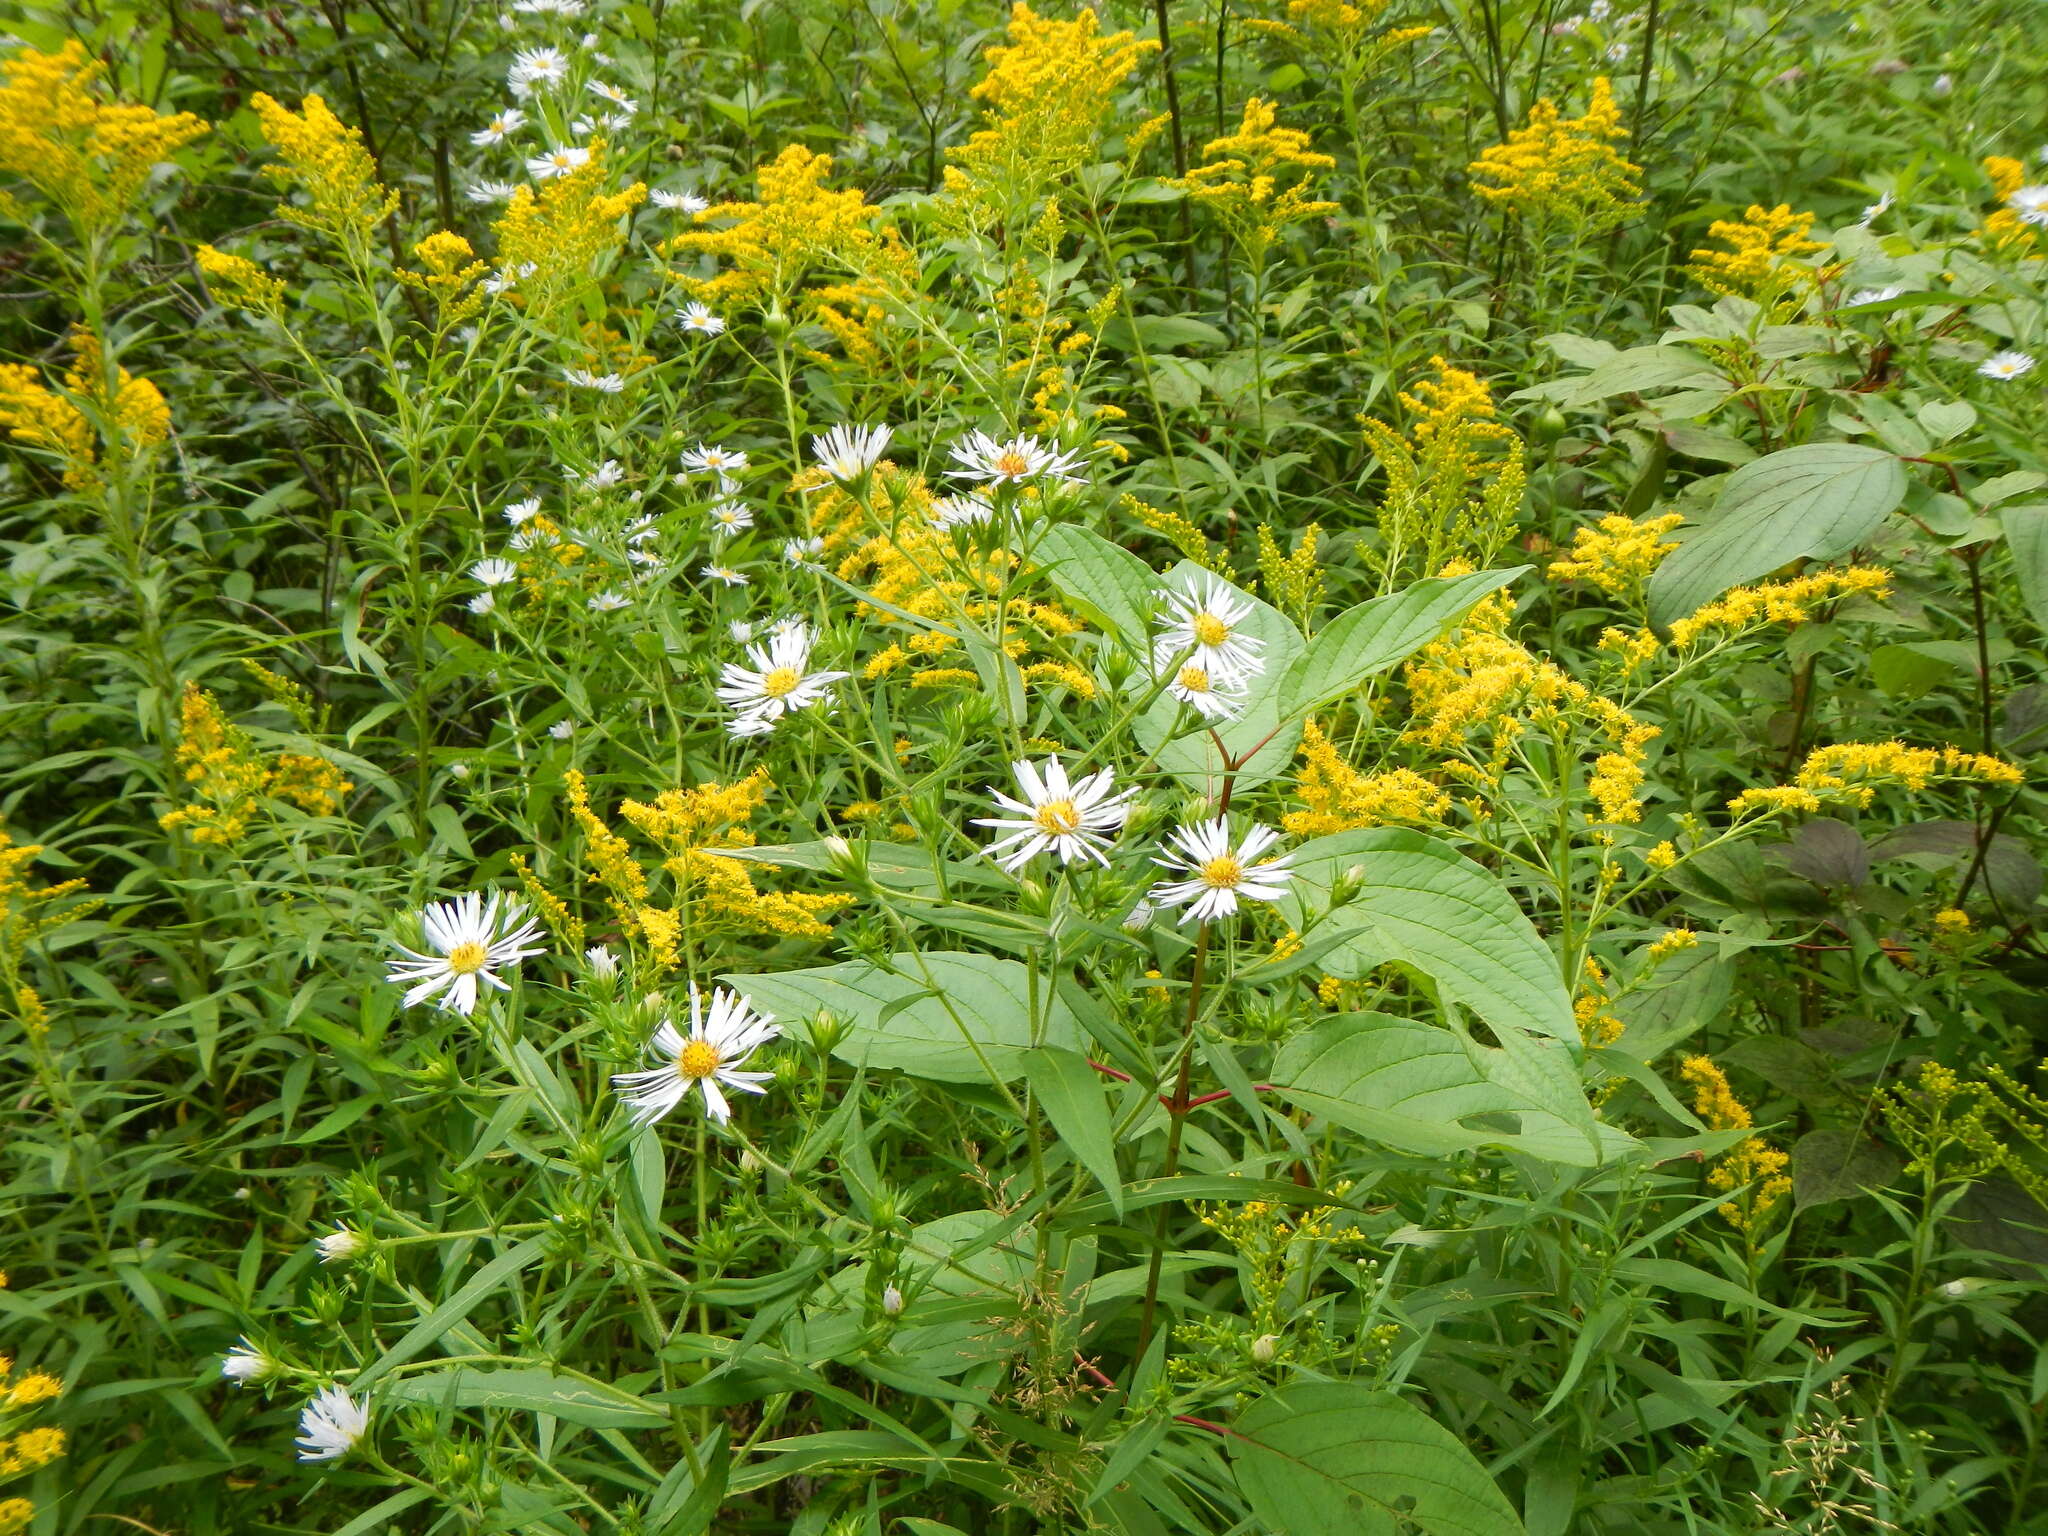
0;39;207;240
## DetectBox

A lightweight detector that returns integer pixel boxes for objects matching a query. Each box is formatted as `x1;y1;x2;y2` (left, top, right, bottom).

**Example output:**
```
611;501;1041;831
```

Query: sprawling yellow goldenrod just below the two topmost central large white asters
797;461;1096;698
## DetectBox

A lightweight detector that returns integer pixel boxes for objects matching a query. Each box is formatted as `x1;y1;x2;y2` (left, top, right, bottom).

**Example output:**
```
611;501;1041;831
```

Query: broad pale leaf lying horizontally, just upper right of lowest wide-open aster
723;950;1081;1083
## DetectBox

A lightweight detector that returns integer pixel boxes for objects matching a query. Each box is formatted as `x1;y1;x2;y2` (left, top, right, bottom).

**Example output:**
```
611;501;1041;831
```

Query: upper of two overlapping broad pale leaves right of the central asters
1282;827;1579;1047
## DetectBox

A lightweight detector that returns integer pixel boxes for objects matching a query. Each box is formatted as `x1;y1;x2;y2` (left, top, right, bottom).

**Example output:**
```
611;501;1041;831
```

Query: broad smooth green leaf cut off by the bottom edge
1229;1382;1522;1536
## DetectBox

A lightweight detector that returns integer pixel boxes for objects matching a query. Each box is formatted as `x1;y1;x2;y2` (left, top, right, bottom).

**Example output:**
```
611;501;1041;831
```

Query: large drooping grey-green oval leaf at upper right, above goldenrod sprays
1649;442;1907;625
